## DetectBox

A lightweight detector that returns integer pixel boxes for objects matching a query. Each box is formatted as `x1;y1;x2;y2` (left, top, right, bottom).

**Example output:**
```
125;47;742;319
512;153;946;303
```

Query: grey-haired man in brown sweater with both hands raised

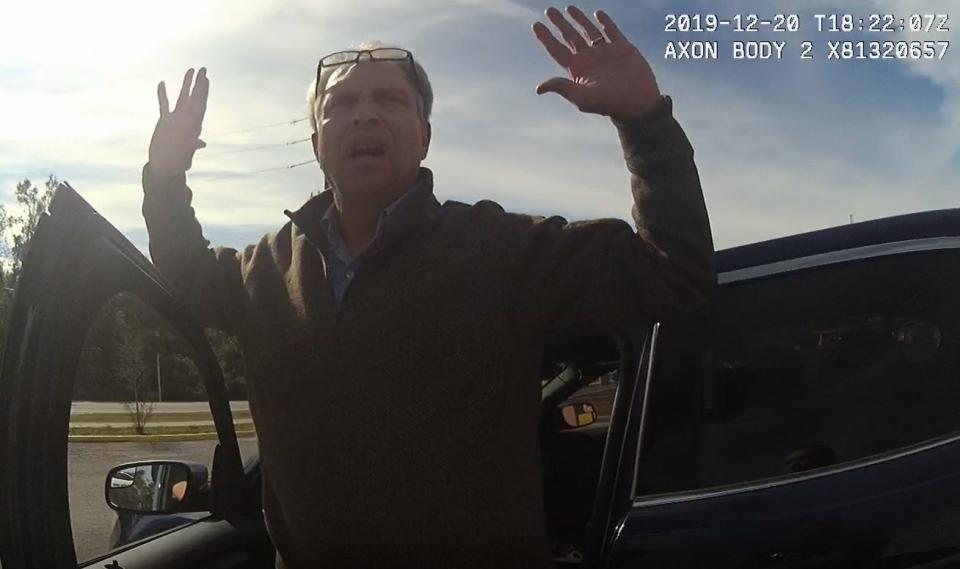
143;7;715;568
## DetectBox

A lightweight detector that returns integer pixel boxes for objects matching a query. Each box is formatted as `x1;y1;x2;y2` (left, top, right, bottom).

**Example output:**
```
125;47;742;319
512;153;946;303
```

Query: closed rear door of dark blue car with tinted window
611;213;960;568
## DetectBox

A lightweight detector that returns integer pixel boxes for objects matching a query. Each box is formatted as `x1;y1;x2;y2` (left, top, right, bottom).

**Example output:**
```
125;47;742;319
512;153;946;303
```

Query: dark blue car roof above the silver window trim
715;209;960;273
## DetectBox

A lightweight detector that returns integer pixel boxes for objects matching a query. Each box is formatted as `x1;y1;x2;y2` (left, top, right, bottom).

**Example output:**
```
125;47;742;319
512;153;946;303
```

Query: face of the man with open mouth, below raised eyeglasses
314;61;430;199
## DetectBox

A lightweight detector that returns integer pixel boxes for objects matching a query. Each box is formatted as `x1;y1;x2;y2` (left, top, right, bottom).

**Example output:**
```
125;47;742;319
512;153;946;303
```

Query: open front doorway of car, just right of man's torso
540;322;658;568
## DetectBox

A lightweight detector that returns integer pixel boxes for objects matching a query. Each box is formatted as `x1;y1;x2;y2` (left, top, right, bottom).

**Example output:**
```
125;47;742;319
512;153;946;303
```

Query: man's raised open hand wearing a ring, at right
533;6;661;120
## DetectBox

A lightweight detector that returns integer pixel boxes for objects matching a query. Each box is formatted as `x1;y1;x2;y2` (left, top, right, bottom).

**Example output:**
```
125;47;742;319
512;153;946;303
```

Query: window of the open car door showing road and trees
67;294;256;561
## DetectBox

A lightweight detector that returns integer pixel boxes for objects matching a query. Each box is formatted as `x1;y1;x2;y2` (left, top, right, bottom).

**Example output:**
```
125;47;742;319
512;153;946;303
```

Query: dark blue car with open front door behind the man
0;184;960;569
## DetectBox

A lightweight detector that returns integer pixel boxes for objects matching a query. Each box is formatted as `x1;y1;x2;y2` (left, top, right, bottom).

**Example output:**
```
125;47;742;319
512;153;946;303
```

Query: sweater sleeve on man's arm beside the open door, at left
143;164;244;334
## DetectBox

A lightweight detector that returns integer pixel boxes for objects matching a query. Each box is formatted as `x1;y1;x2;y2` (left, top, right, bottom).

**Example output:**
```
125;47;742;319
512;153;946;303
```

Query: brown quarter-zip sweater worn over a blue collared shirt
143;98;715;568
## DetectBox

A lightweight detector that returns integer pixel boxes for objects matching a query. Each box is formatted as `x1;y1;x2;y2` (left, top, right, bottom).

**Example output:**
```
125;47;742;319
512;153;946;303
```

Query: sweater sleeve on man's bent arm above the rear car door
505;97;716;334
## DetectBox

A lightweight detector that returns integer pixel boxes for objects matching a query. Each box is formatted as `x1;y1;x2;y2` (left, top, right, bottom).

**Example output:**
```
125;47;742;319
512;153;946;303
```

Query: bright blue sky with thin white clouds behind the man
0;0;960;251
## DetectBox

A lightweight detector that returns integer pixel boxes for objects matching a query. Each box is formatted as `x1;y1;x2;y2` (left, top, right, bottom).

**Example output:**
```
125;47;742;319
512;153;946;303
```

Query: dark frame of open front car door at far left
0;184;272;569
